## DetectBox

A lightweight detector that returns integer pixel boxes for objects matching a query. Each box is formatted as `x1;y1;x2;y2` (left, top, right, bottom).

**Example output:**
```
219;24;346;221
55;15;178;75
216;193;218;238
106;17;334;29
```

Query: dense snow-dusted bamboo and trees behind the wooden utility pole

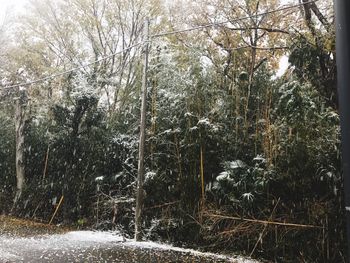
0;1;346;262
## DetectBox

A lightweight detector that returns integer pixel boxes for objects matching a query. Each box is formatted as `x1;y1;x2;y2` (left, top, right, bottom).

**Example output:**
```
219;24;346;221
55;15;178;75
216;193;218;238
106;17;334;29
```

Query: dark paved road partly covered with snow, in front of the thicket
0;231;257;263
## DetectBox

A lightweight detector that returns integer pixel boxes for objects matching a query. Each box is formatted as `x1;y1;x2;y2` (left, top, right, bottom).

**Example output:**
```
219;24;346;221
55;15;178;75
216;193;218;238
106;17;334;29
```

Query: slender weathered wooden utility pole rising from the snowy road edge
135;18;149;241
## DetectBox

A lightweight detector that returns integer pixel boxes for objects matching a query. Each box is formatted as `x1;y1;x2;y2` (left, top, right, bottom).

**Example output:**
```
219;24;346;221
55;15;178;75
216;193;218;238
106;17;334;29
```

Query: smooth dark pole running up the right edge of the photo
334;0;350;262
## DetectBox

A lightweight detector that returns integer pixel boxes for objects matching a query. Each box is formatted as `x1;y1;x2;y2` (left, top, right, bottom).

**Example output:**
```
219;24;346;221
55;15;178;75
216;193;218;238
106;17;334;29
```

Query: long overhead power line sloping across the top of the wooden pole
1;0;318;90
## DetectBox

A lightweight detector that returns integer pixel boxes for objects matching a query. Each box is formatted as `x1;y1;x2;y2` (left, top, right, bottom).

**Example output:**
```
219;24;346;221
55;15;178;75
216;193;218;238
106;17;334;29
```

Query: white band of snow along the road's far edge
0;231;258;263
